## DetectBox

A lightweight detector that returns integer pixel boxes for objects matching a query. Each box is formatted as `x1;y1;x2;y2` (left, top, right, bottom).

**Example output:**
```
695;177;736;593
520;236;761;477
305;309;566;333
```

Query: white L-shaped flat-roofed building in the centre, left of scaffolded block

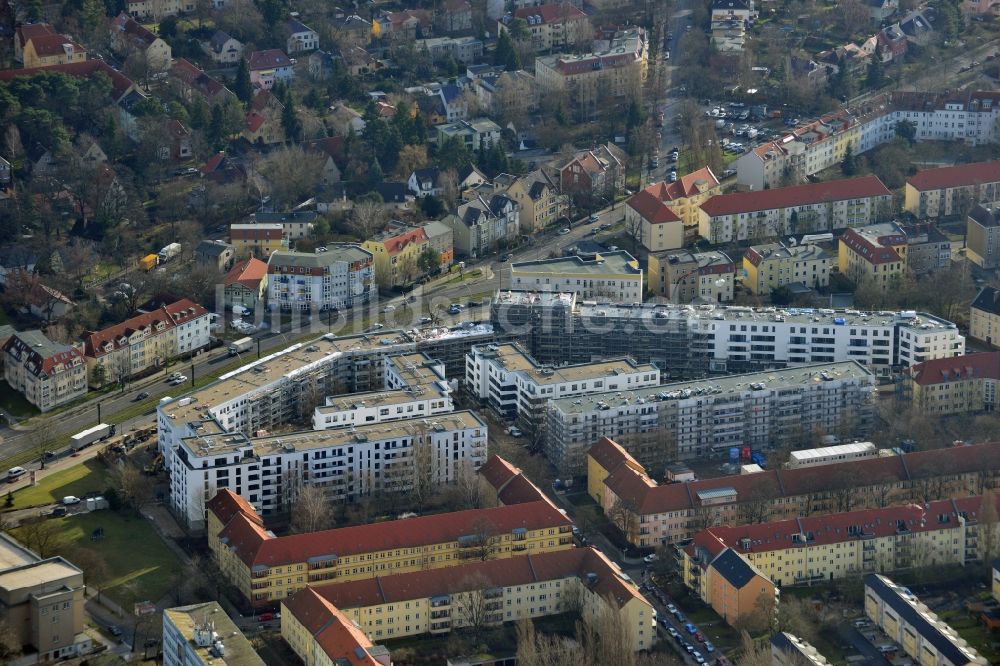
465;344;660;430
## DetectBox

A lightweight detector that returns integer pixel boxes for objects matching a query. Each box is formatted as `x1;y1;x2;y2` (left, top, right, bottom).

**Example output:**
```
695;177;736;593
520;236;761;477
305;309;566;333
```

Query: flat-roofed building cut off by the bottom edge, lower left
163;601;264;666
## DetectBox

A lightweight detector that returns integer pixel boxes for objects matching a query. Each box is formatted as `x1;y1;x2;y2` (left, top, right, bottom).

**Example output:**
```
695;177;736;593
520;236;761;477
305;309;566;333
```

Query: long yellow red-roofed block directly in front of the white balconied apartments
208;489;573;606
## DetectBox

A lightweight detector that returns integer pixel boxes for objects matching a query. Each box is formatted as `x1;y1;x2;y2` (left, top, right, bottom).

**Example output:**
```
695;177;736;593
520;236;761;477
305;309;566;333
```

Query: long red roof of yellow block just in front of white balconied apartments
220;501;572;567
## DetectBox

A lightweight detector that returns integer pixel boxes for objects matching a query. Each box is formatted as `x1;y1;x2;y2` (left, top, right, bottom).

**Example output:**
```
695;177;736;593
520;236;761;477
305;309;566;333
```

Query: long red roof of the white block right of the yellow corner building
701;176;892;216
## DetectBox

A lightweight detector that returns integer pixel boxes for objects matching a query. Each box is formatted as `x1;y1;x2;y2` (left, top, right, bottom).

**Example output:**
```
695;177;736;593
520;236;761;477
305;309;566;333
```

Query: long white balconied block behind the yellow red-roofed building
169;411;487;528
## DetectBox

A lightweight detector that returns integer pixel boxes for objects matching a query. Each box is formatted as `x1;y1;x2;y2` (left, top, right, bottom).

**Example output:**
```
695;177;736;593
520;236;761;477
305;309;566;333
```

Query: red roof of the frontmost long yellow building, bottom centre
315;548;642;608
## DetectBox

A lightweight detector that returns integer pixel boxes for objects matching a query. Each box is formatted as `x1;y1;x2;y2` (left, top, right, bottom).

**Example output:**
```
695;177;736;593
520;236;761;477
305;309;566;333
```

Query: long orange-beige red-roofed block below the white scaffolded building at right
587;438;1000;547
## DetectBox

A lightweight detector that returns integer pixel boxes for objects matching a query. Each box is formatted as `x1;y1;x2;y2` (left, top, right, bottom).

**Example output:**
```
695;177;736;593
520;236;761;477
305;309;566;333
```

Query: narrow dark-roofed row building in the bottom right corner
865;574;989;666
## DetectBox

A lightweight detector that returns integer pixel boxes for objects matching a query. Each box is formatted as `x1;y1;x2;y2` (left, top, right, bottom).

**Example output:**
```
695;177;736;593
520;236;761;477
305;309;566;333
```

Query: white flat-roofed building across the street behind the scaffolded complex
510;250;643;303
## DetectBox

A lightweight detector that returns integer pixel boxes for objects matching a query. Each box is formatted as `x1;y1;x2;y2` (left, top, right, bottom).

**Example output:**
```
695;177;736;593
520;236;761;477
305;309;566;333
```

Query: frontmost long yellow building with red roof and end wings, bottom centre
292;548;656;648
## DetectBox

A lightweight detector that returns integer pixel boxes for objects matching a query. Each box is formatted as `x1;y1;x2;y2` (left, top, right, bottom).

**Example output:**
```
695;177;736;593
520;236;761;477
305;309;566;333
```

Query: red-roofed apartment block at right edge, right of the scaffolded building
903;352;1000;416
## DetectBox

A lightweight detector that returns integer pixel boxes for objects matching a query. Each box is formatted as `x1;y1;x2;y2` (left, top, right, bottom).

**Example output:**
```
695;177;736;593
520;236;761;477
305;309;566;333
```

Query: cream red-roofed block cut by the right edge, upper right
903;162;1000;220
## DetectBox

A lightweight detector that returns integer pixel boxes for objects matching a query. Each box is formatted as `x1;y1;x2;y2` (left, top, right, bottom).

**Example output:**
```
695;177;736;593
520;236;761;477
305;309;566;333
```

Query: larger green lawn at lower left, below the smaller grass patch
13;510;181;609
